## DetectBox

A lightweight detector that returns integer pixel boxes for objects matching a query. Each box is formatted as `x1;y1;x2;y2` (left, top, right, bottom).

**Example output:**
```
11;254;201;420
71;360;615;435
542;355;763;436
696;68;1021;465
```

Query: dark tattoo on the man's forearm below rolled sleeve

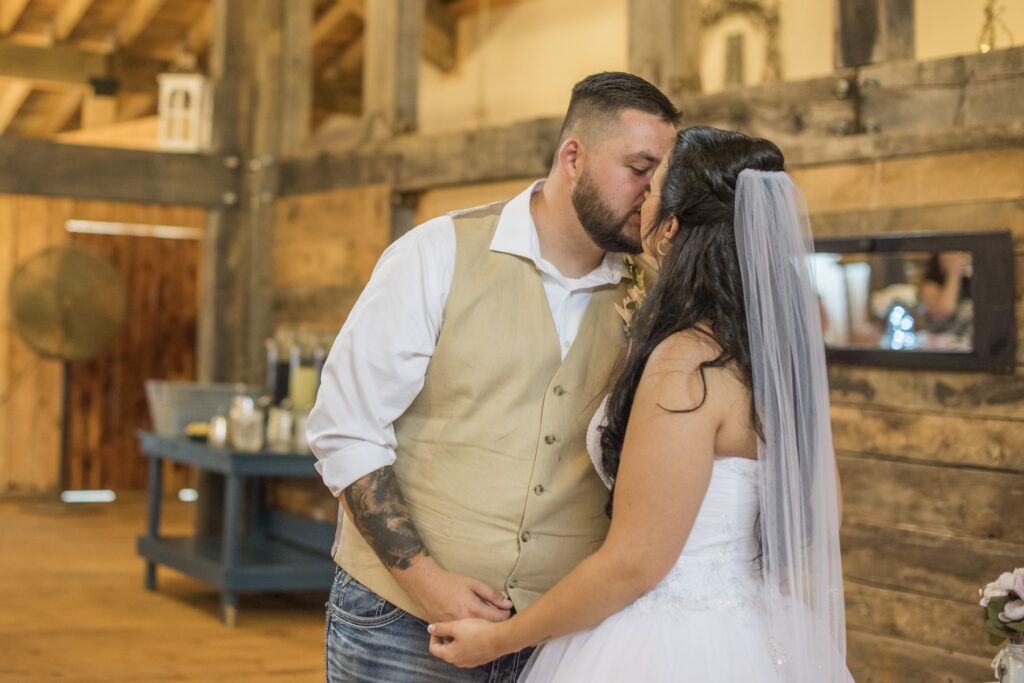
344;467;429;569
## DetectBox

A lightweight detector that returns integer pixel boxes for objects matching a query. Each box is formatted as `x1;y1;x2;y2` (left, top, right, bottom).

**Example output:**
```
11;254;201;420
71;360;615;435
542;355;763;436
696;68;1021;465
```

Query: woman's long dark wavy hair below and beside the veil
601;126;784;515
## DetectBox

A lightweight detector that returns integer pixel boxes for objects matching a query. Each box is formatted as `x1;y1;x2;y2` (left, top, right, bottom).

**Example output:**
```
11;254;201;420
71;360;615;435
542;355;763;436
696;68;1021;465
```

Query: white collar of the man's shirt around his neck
490;179;626;290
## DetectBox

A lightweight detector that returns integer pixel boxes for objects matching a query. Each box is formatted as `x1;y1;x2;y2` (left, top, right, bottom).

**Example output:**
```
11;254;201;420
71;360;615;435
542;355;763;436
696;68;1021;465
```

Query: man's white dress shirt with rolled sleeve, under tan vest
306;180;625;497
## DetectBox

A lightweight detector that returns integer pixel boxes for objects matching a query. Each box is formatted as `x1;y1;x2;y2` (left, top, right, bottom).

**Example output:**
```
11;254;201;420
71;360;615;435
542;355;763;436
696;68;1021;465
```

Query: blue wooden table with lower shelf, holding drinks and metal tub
138;431;335;626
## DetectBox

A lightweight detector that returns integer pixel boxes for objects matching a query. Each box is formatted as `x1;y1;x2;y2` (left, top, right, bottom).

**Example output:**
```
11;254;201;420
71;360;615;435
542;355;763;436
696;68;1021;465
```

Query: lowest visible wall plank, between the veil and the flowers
846;629;992;683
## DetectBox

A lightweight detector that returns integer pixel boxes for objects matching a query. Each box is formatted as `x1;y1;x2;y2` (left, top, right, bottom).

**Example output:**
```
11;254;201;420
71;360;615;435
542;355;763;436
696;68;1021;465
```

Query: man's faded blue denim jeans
324;567;534;683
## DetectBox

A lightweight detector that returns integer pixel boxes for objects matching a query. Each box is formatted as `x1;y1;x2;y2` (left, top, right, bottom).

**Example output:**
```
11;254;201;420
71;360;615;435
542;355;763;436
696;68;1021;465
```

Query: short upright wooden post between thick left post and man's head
362;0;425;139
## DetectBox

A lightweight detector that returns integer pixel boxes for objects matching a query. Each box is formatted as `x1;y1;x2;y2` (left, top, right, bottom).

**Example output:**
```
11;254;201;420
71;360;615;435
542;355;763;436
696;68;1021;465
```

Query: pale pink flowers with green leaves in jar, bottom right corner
978;567;1024;683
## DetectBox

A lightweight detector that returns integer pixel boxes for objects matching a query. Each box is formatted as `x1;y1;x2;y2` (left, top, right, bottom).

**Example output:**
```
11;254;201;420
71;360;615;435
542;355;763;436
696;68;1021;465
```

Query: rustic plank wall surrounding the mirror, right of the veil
793;146;1024;683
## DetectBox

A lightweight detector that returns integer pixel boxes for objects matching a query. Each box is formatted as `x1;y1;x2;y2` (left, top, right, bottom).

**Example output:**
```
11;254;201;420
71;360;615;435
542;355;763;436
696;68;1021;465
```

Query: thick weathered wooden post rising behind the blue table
198;0;313;382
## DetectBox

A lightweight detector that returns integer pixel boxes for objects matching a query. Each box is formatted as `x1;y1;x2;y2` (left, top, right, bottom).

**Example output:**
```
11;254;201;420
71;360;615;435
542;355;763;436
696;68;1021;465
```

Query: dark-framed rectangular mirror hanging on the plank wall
813;231;1017;372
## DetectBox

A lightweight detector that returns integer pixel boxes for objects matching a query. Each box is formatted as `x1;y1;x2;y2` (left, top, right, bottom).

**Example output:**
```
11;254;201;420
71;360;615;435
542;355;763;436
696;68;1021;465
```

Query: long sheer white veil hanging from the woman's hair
734;169;852;683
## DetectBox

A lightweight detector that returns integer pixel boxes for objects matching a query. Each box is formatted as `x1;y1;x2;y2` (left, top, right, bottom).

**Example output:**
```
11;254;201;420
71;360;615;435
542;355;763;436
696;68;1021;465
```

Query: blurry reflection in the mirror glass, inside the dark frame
814;250;974;353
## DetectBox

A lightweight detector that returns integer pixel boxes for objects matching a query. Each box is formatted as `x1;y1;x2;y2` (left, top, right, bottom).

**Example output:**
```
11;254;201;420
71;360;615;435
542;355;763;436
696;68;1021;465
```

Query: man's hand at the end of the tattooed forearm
392;557;512;622
